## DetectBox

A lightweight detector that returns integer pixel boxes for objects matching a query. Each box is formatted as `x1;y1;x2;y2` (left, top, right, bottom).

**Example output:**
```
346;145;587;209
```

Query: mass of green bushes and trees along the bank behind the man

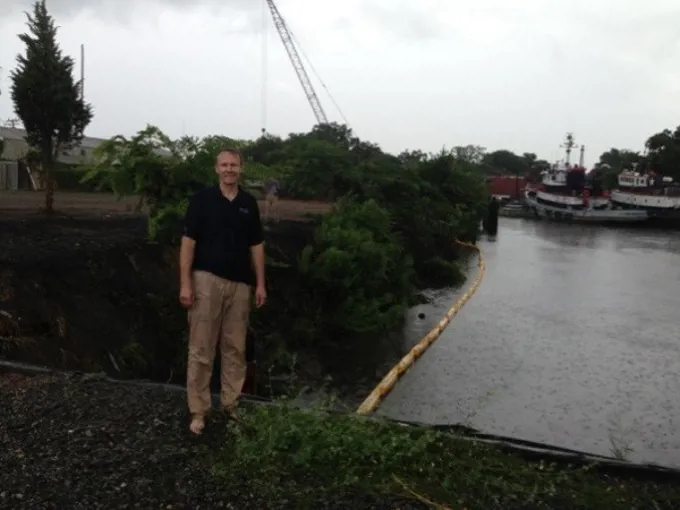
63;124;488;394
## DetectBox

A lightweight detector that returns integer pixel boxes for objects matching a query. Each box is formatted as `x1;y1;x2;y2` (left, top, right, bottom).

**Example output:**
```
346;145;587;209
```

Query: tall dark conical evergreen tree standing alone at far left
10;0;92;213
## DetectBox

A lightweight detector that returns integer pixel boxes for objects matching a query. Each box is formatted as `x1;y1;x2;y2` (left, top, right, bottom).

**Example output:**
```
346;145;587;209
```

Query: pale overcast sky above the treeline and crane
0;0;680;164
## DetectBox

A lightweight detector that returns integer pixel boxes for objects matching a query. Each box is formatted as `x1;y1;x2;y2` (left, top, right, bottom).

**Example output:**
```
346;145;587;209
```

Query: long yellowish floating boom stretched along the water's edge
356;241;486;415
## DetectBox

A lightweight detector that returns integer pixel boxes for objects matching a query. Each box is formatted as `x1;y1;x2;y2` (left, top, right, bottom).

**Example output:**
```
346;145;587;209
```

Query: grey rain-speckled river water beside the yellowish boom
378;218;680;466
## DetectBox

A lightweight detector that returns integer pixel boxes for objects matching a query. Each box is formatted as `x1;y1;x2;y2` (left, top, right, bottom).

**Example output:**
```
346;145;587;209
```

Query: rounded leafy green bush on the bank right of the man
299;199;413;335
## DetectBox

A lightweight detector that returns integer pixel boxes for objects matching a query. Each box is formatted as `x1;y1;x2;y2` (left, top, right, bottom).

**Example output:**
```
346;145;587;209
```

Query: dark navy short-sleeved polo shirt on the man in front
184;186;264;285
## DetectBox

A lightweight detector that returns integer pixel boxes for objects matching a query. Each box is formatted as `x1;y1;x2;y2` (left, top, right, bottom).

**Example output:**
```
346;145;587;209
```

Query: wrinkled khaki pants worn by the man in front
187;271;250;416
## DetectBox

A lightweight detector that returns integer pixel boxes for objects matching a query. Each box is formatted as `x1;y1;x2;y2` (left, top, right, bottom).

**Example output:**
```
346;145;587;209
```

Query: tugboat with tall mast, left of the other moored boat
525;133;649;223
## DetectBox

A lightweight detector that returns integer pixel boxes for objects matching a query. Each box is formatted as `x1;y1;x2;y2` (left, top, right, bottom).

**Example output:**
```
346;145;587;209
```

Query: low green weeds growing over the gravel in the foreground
214;405;680;510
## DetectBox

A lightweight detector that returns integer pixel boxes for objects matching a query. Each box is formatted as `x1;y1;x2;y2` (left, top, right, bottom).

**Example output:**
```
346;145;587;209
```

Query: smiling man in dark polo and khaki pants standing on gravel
179;149;267;434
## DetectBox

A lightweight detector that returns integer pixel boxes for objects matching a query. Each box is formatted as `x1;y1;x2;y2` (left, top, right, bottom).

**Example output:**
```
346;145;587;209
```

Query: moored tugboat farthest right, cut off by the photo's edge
611;168;680;224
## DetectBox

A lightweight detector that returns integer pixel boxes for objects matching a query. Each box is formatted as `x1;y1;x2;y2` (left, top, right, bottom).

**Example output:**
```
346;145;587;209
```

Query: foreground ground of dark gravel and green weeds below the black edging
0;373;680;510
